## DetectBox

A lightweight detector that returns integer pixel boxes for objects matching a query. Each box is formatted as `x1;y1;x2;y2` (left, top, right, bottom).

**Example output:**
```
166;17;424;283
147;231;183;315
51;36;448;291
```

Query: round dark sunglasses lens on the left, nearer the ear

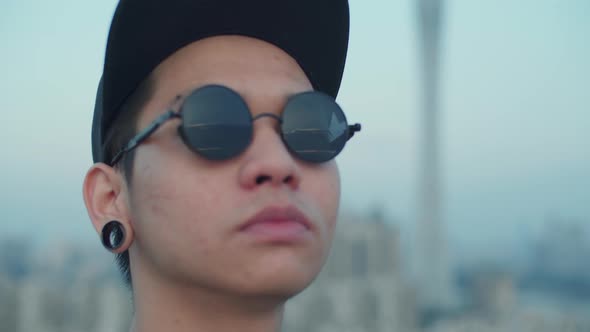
180;85;252;160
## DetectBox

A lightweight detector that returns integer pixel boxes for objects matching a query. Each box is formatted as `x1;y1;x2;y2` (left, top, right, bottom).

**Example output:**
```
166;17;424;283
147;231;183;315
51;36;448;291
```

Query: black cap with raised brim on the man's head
92;0;349;162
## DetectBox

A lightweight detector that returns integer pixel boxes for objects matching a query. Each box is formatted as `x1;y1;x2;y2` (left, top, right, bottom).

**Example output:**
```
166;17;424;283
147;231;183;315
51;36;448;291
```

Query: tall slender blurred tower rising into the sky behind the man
416;0;450;310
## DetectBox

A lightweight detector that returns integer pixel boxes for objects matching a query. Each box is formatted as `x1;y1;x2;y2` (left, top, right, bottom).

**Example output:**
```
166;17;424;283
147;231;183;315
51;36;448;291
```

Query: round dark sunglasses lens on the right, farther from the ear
281;92;348;163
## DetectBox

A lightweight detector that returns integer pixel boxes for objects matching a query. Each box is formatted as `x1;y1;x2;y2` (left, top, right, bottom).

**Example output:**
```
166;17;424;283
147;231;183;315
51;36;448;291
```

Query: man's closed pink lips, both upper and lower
239;206;312;242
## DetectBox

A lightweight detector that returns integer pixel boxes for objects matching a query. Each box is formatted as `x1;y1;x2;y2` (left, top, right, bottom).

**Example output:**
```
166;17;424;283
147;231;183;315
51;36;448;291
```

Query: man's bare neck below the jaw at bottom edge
130;274;284;332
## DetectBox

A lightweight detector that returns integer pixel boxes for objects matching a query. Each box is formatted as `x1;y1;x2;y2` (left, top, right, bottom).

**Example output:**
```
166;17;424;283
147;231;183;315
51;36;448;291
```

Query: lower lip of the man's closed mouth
242;221;308;242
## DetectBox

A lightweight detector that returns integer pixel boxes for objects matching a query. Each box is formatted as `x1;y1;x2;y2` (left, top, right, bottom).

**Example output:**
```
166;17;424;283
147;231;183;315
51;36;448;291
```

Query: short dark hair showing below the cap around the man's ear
103;75;154;286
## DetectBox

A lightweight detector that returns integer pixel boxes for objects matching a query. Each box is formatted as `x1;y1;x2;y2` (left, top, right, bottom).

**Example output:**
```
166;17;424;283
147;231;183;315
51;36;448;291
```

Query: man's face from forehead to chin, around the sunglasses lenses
128;36;340;296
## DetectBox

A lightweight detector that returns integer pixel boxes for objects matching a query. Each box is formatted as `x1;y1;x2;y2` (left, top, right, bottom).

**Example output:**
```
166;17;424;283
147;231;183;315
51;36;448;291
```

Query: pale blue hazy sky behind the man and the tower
0;0;590;260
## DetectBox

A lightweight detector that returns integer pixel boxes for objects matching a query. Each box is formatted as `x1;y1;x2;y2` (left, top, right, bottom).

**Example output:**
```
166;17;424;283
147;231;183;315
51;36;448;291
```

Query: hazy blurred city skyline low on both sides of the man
0;215;590;332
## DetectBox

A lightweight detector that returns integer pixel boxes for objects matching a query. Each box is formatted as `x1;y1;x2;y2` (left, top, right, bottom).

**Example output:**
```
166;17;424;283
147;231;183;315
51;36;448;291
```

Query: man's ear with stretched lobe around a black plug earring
82;163;134;253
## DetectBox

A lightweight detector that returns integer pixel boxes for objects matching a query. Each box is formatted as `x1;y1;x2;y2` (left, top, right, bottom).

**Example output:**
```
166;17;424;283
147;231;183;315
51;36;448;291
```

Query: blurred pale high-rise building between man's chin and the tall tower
285;214;416;332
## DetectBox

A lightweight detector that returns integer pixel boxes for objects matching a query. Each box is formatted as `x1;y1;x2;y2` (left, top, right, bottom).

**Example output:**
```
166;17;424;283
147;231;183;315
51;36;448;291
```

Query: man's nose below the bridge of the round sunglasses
239;117;301;189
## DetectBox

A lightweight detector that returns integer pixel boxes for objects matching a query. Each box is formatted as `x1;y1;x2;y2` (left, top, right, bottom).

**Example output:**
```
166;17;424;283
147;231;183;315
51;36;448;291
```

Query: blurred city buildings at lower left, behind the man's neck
0;241;131;332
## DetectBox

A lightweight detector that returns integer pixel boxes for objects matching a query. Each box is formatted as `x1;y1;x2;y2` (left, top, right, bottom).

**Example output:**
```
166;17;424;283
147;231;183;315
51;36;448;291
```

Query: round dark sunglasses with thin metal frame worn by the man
110;85;361;166
